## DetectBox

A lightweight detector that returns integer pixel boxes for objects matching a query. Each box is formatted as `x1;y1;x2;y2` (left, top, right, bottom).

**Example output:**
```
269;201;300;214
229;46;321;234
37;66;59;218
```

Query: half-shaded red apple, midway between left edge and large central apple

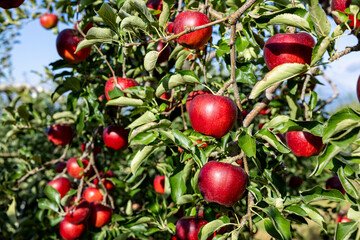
103;125;129;150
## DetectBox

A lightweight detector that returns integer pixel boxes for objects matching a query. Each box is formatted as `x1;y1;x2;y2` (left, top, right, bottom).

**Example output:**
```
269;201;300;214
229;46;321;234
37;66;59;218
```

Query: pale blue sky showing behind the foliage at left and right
7;14;360;109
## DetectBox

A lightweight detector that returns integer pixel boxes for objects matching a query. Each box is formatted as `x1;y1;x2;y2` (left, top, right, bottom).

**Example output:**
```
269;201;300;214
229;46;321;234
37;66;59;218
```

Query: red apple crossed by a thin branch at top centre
174;12;212;49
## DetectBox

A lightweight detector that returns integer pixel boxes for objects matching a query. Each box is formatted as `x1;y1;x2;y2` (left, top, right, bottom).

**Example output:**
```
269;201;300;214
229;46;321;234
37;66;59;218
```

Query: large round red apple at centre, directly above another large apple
189;95;237;138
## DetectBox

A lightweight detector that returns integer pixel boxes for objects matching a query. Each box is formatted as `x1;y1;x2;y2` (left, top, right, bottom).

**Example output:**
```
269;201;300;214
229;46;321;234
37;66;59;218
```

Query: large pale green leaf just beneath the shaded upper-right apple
249;63;309;99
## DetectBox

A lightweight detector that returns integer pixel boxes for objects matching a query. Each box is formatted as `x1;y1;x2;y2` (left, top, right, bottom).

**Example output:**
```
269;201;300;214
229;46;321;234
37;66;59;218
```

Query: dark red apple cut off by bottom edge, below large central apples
175;217;208;240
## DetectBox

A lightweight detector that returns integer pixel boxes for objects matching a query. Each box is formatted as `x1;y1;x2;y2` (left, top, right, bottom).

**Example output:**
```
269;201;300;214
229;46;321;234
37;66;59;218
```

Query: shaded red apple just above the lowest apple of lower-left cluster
65;200;91;224
